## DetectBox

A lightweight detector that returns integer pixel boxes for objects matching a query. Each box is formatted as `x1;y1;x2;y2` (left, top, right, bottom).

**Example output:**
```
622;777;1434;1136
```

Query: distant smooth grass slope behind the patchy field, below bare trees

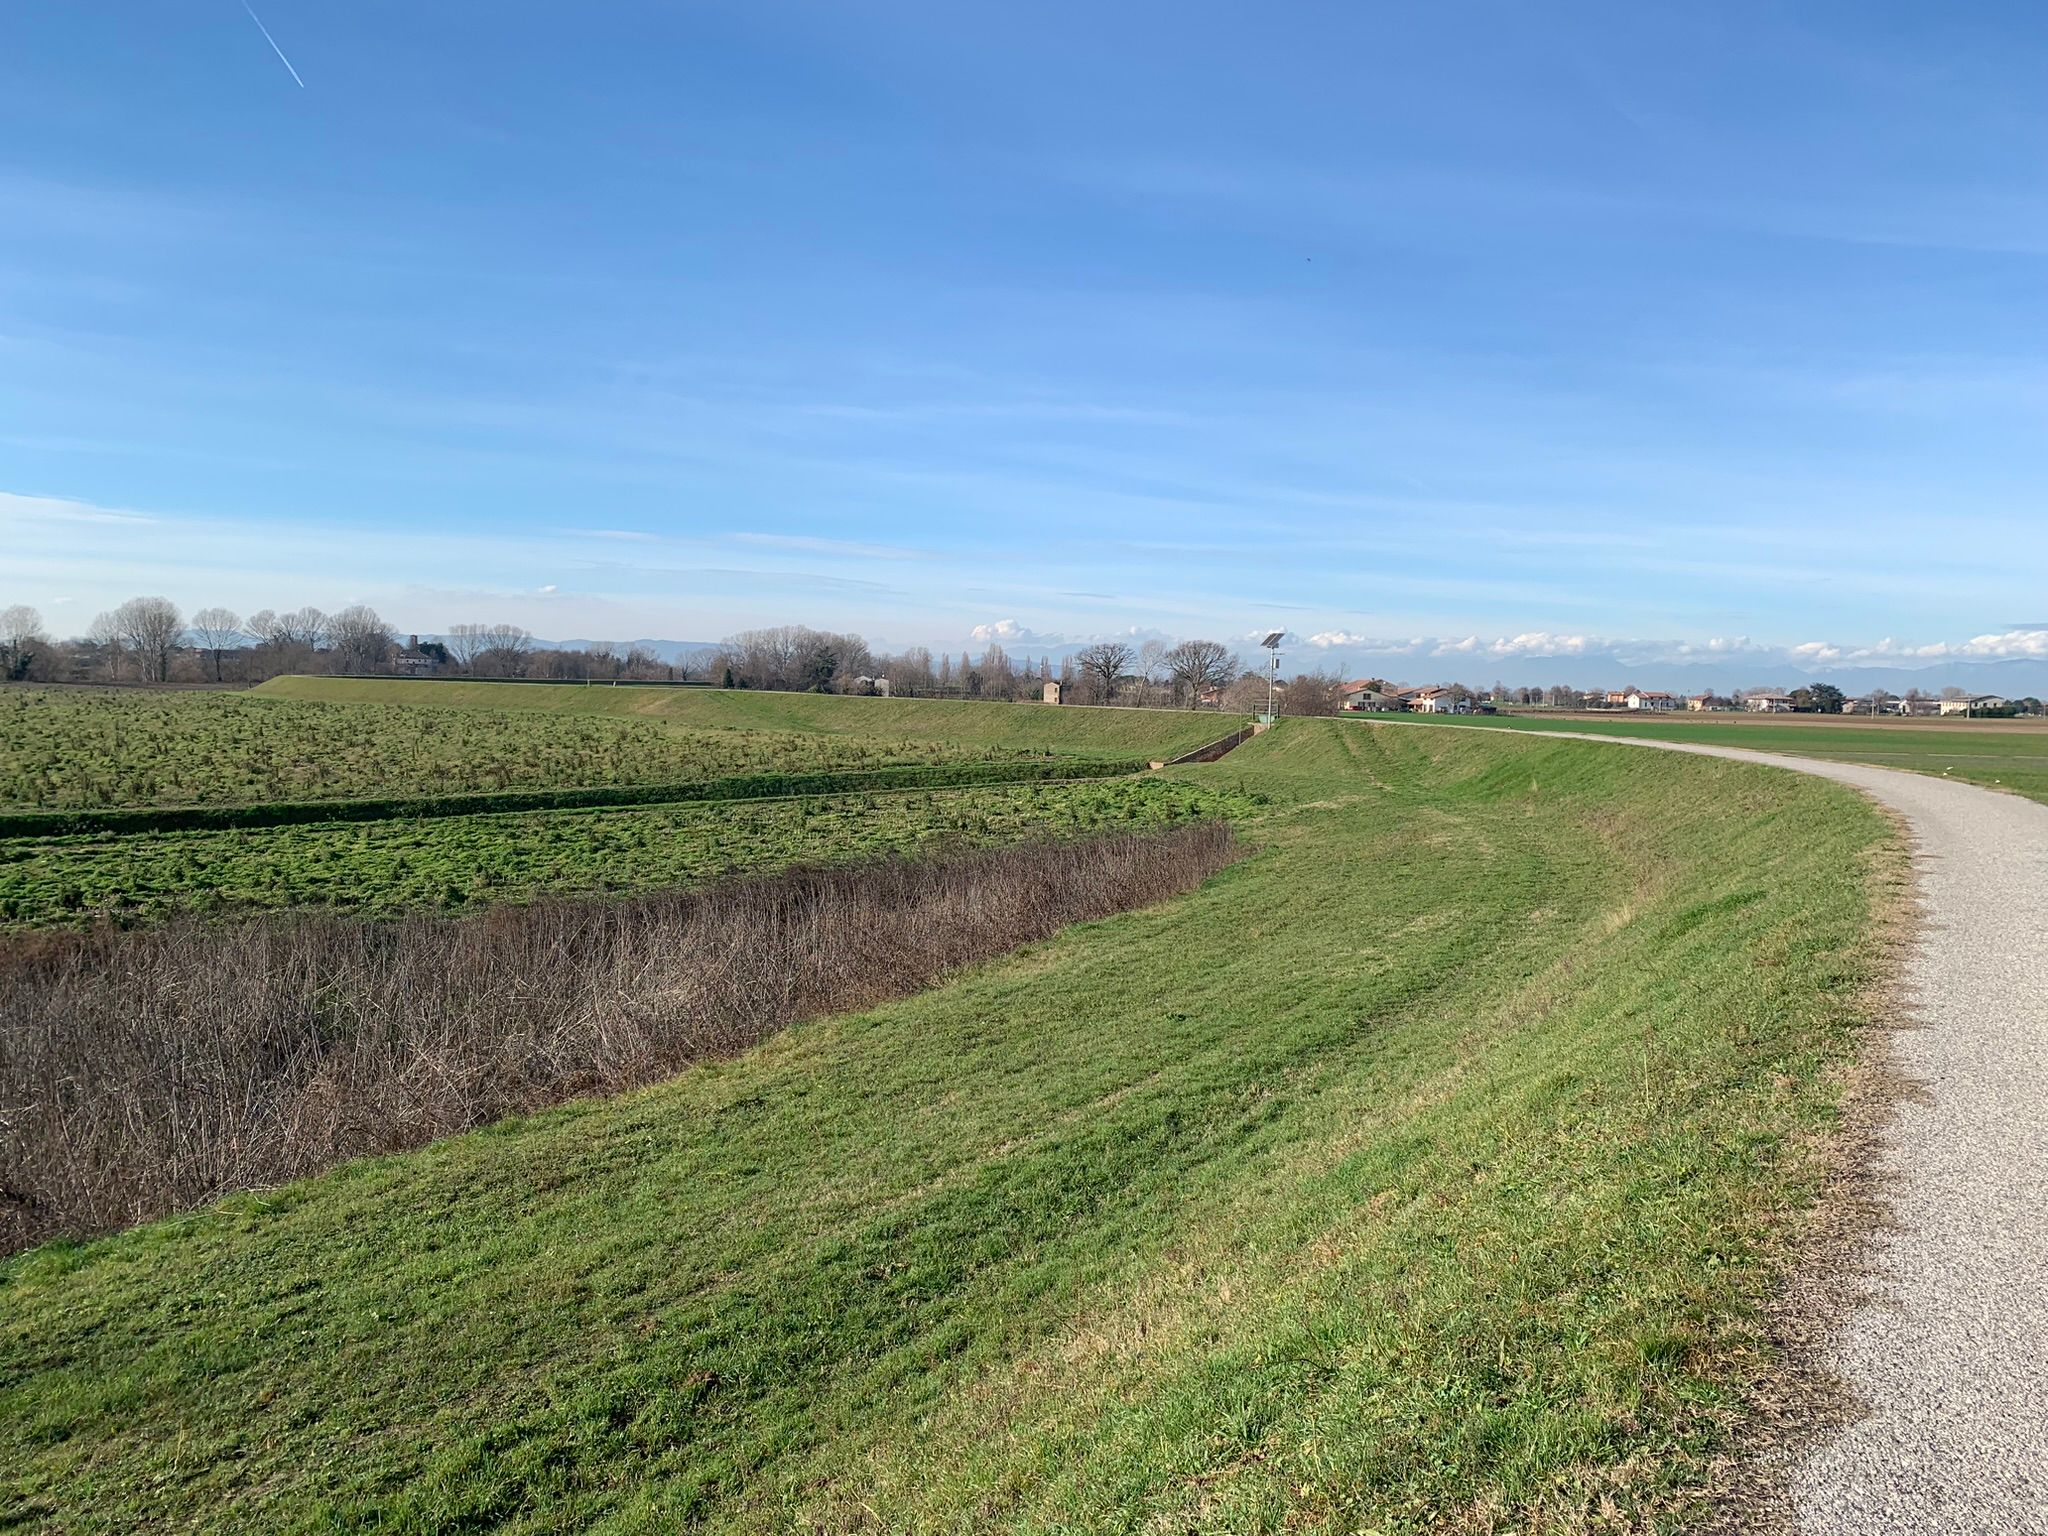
254;678;1243;758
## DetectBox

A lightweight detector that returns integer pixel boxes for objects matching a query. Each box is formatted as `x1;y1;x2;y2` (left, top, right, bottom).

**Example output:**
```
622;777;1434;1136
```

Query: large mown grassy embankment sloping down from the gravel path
0;721;1894;1532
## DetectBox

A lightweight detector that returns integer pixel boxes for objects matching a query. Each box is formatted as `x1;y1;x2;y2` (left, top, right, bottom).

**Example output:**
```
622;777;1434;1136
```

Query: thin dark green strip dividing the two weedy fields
0;758;1149;838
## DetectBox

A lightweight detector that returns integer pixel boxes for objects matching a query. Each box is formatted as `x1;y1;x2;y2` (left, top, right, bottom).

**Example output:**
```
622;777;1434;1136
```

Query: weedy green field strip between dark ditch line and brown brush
0;778;1255;932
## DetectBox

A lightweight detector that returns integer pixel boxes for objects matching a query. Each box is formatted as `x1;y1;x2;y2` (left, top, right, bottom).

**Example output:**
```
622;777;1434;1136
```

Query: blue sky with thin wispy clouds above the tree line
0;0;2048;670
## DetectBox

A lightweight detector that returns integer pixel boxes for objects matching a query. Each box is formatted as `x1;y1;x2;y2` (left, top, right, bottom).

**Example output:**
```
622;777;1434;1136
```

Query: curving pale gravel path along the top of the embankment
1530;731;2048;1536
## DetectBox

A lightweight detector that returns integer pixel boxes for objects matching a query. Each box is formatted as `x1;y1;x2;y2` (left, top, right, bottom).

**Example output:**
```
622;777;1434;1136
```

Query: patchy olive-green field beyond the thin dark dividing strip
0;688;1018;809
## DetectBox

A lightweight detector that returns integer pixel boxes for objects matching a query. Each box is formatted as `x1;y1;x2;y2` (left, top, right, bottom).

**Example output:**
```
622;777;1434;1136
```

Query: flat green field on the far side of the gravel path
1413;715;2048;801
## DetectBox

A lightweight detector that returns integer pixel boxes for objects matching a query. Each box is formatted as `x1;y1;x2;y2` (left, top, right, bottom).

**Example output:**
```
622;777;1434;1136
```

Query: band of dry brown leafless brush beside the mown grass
0;821;1233;1251
